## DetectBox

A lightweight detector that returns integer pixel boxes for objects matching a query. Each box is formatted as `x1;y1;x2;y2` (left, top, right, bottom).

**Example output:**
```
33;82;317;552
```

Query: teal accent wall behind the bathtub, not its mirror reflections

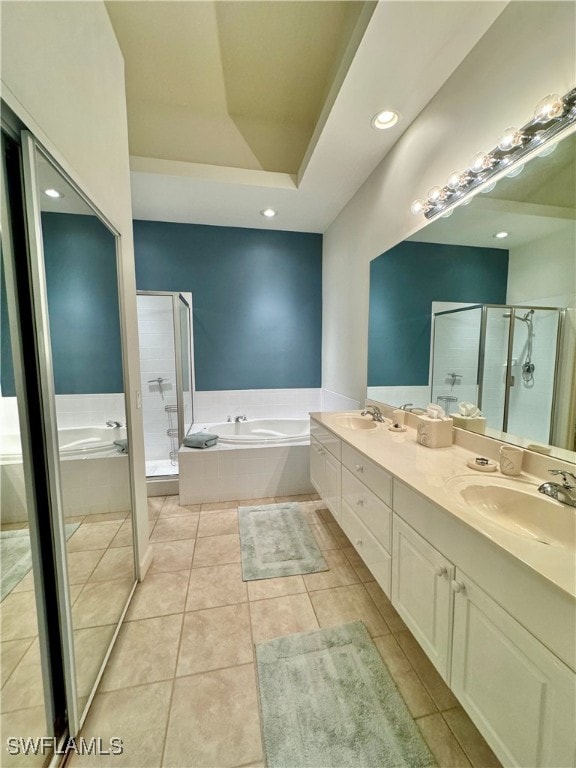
134;221;322;390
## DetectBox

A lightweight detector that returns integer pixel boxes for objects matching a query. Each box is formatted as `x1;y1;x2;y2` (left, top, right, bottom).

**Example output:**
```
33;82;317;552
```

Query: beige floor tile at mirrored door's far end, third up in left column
126;571;190;621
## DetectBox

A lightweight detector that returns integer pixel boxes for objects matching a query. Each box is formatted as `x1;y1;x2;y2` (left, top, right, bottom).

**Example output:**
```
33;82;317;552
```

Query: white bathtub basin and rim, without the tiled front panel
202;419;310;447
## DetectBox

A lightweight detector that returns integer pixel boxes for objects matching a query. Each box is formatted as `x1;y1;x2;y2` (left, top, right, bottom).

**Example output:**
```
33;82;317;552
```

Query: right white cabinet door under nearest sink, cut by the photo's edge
451;571;576;768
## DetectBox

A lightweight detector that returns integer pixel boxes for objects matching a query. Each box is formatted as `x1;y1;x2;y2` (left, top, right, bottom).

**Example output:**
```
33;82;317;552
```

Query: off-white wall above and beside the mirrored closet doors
1;1;148;576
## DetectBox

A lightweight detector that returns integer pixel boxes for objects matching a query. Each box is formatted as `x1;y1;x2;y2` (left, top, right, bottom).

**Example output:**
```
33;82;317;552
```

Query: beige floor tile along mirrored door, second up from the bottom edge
98;614;183;692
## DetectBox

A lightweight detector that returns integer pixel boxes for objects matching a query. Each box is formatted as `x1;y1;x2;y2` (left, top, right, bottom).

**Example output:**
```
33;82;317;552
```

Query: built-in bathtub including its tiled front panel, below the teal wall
178;419;315;504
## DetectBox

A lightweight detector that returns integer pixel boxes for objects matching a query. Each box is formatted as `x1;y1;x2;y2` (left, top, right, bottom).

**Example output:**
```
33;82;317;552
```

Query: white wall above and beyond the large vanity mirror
322;2;575;400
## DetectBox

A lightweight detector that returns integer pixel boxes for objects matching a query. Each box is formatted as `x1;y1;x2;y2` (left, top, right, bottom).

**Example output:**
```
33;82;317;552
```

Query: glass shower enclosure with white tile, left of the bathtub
137;291;194;478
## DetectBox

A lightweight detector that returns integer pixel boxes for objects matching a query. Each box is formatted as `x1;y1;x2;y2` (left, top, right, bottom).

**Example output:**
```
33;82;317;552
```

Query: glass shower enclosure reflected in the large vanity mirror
432;305;568;447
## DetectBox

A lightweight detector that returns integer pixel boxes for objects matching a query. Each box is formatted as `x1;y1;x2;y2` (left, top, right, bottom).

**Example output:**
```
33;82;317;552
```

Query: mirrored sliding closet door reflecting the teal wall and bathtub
24;139;135;734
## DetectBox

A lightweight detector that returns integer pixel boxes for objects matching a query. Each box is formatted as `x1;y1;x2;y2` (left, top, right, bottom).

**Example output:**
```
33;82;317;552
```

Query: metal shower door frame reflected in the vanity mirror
478;304;566;444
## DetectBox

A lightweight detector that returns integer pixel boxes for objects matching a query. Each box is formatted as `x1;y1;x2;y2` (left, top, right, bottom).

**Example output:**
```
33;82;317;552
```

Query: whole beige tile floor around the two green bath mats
64;497;499;768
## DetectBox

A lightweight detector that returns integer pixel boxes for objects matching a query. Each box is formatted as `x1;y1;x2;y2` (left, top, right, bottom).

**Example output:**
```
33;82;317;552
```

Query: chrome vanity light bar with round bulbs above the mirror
410;88;576;219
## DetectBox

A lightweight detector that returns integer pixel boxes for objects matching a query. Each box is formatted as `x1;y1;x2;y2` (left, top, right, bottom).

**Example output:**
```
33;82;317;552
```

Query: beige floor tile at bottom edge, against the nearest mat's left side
163;664;262;768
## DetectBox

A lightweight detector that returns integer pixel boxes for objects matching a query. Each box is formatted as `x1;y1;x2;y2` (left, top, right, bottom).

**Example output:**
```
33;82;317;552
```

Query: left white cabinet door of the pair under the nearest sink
392;515;454;679
